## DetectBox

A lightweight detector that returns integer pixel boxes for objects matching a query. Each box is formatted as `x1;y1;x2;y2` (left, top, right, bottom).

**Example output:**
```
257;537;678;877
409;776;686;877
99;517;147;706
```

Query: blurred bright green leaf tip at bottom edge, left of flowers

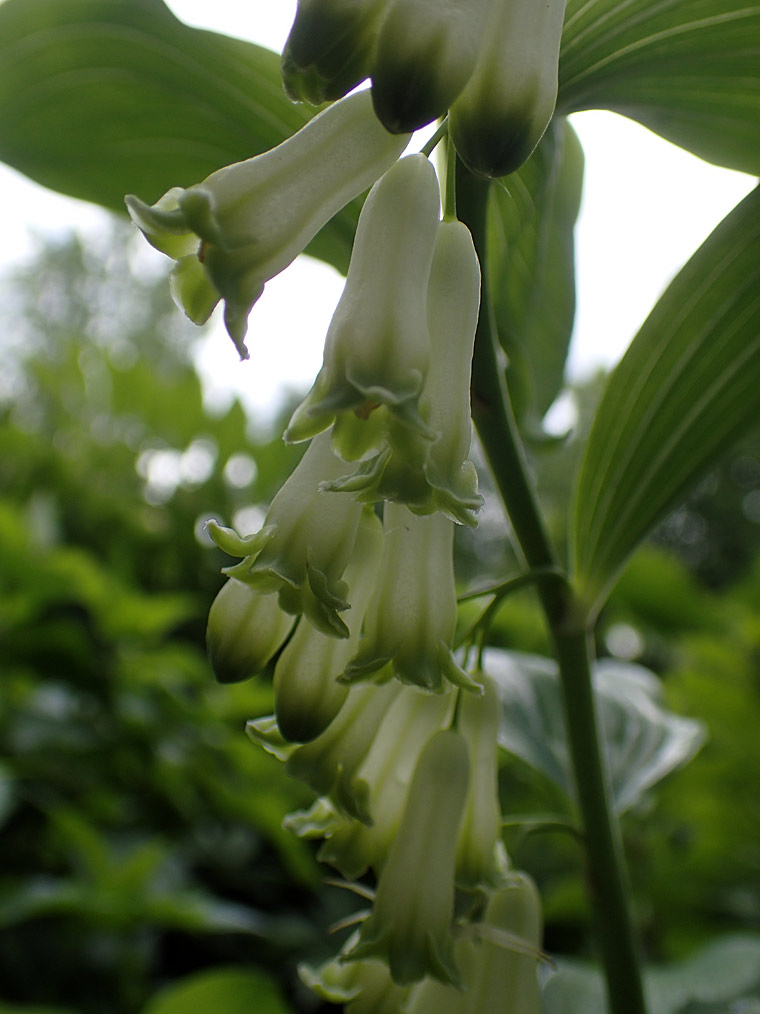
143;967;288;1014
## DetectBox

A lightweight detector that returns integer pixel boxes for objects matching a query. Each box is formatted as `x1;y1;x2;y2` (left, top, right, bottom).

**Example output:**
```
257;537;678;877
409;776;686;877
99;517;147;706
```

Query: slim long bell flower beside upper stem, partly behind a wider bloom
323;221;483;525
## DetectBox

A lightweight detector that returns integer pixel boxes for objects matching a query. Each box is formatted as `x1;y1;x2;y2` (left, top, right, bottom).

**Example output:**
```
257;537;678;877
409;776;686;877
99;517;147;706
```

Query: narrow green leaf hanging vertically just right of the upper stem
488;119;584;431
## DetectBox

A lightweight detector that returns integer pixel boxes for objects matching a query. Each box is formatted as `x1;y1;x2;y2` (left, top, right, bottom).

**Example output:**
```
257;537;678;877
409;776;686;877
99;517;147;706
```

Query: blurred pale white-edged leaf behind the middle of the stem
484;649;704;813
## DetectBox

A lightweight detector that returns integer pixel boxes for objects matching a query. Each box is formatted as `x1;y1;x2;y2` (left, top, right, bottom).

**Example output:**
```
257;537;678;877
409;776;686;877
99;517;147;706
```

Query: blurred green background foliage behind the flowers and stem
0;220;760;1014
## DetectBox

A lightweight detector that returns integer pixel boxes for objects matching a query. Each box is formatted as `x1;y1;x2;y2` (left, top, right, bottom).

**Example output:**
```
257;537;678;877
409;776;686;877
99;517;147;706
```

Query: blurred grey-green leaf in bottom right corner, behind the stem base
541;935;760;1014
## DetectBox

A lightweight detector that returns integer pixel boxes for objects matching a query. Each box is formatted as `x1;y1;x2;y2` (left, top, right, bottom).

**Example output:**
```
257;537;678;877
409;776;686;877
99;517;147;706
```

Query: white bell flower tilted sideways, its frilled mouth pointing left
126;92;408;358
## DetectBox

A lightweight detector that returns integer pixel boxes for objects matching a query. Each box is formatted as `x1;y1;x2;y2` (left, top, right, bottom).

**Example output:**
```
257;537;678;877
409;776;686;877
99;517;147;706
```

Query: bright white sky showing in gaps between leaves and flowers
0;0;755;425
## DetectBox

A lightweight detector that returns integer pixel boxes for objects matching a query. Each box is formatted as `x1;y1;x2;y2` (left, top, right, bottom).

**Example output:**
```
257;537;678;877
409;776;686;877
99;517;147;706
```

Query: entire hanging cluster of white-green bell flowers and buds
128;0;563;1014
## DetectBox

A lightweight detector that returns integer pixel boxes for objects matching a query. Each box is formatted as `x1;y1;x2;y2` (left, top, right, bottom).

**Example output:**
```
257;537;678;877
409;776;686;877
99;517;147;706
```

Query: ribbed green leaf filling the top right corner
557;0;760;175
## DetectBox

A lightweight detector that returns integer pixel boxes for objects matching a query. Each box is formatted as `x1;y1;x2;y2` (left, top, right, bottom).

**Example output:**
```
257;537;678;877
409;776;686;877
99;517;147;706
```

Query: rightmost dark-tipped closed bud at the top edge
449;0;565;176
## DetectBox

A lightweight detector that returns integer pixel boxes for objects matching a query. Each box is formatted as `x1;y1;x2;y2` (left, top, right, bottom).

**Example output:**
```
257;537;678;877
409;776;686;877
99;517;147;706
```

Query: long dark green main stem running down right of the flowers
457;165;647;1014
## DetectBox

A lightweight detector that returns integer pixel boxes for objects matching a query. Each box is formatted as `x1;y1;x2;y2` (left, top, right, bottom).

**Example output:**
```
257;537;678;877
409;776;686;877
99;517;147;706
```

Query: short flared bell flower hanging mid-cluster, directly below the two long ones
340;503;479;693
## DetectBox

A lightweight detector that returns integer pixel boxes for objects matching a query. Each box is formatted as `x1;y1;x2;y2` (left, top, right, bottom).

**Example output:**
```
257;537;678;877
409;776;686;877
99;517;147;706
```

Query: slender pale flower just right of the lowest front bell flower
456;677;508;888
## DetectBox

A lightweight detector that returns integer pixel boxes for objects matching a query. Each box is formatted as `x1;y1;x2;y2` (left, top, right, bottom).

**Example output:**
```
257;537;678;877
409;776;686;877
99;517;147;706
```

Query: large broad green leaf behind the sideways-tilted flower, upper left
0;0;358;270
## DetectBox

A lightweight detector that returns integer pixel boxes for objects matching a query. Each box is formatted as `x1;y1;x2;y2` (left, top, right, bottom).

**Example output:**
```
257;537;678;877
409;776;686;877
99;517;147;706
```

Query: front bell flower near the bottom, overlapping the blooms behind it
344;729;476;986
